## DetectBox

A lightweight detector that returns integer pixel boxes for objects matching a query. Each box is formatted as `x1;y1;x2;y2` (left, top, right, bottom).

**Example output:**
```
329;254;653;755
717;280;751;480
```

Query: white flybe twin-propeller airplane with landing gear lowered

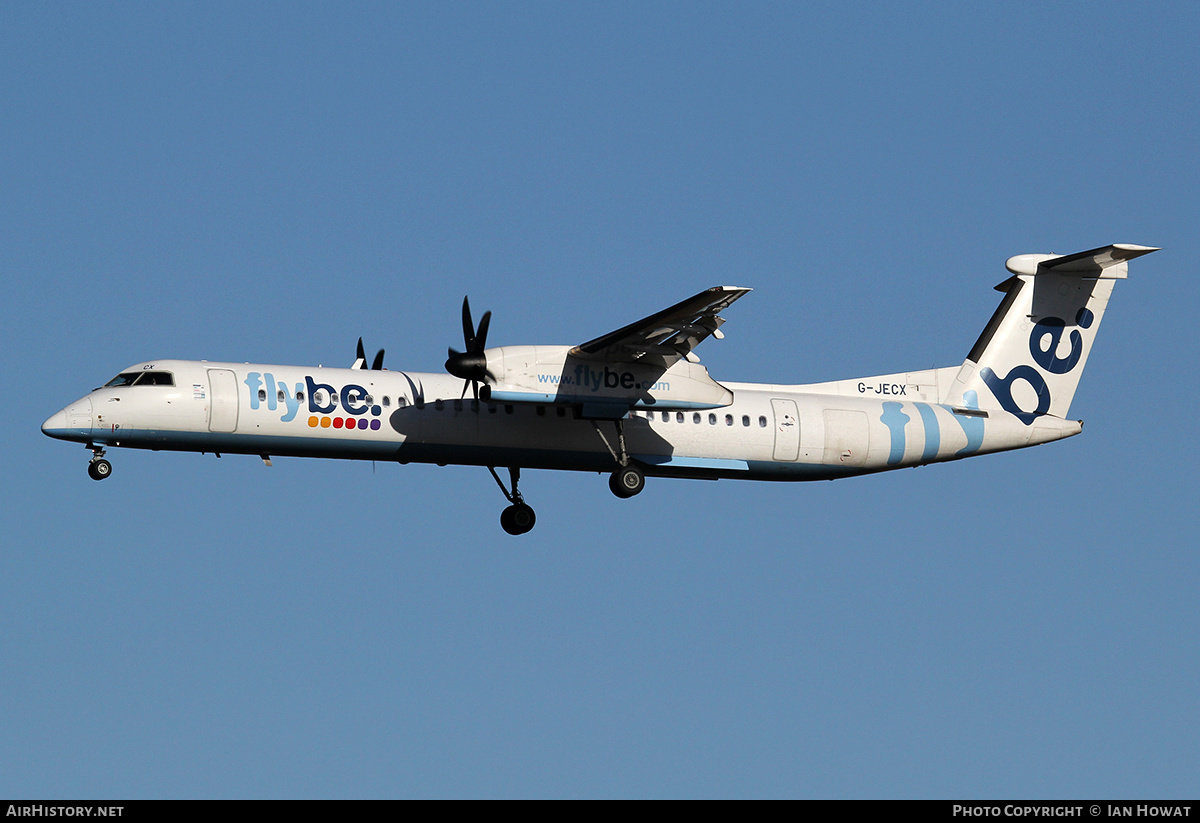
42;244;1158;535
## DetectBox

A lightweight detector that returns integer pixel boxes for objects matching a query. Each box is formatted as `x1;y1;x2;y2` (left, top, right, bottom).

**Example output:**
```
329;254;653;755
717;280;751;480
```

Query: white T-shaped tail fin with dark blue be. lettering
946;244;1158;426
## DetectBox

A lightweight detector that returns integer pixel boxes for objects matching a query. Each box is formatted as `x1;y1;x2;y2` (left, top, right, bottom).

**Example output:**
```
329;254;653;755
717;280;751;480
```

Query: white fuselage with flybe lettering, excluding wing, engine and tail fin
42;360;1081;480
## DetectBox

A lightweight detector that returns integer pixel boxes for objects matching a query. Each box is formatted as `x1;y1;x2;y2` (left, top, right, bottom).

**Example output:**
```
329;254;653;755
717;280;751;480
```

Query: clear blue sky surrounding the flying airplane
0;2;1200;798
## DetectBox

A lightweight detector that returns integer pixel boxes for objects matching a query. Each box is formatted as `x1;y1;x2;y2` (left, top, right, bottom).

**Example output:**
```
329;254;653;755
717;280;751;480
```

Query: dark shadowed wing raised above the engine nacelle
571;286;750;368
